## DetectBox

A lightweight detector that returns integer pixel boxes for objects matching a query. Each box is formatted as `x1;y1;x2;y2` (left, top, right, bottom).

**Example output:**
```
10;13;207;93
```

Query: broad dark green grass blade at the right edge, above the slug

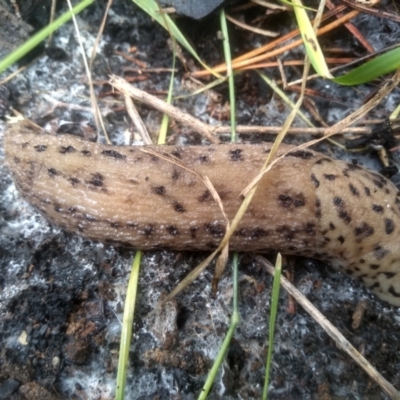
333;47;400;85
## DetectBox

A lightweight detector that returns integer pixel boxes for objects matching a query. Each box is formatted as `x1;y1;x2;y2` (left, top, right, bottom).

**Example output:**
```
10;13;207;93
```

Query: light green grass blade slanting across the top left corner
0;0;95;73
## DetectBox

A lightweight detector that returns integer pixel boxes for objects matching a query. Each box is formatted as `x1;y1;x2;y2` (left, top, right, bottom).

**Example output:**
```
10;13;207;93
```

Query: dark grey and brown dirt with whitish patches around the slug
0;0;400;400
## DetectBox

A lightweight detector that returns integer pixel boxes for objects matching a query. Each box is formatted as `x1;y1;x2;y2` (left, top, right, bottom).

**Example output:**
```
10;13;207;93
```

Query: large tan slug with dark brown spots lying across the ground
4;122;400;306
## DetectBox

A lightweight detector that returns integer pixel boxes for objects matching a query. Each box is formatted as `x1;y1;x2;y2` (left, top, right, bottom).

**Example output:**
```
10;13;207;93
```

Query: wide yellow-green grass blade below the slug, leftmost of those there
115;251;142;400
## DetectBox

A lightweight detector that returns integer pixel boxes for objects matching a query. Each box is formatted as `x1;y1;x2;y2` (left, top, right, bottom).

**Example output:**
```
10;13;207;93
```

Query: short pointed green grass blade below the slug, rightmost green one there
262;253;282;400
